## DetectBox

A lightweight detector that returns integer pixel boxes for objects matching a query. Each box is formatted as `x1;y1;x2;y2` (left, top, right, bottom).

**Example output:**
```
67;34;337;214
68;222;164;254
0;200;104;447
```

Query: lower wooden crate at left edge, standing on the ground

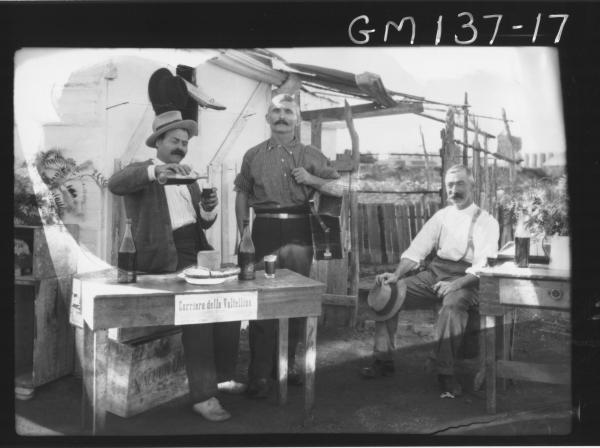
15;278;74;388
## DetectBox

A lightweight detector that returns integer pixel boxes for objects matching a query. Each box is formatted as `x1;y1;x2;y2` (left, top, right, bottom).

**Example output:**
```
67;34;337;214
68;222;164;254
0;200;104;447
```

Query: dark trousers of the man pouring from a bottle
173;225;240;403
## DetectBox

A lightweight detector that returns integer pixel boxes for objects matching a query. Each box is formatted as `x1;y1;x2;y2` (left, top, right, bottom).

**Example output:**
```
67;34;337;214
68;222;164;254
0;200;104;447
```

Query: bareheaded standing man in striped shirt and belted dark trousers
235;94;341;398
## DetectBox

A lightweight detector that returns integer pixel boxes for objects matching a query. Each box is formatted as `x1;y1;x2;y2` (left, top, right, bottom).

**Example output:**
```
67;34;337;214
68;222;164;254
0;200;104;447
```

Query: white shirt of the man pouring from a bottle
148;159;217;230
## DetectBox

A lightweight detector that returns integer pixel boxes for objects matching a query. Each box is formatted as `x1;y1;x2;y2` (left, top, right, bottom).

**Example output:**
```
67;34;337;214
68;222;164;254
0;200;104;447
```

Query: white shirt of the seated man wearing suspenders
401;204;500;275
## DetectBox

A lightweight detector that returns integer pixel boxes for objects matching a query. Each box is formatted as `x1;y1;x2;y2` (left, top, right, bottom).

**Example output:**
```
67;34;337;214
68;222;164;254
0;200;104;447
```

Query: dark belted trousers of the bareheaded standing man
248;215;313;382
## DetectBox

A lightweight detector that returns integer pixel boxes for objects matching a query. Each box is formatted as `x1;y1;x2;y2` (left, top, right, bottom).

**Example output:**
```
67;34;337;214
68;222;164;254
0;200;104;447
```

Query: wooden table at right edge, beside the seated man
479;261;571;413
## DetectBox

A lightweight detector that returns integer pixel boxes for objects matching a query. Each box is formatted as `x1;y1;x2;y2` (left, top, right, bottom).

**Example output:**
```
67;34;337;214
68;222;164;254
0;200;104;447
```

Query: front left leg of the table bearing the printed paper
92;330;108;435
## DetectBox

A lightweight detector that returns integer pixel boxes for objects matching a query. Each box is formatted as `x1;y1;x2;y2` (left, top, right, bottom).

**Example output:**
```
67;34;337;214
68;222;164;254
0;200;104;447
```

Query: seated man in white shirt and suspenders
361;165;499;398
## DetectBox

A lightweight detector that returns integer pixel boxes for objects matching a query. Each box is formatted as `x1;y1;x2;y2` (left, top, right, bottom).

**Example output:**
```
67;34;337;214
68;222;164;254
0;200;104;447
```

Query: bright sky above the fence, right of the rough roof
273;47;565;158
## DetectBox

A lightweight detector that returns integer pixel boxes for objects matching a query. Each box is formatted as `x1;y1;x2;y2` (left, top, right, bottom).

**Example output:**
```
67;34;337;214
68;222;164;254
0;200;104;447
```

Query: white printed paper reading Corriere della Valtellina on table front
175;291;258;325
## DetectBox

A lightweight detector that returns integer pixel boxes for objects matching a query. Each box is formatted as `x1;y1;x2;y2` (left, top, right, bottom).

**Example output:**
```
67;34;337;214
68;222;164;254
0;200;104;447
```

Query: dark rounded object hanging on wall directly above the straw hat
148;68;188;115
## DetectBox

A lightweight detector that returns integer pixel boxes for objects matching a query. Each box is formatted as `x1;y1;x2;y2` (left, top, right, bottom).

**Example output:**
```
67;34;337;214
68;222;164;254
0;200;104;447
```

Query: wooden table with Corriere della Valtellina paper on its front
73;269;325;434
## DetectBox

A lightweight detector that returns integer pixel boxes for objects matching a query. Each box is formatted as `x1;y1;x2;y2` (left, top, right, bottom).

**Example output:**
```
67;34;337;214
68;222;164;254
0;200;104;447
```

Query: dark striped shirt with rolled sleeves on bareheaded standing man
234;139;340;210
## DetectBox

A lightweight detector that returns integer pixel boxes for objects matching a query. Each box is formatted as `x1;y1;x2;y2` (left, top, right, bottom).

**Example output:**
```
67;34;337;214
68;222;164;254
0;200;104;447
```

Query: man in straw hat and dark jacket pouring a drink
108;104;245;421
